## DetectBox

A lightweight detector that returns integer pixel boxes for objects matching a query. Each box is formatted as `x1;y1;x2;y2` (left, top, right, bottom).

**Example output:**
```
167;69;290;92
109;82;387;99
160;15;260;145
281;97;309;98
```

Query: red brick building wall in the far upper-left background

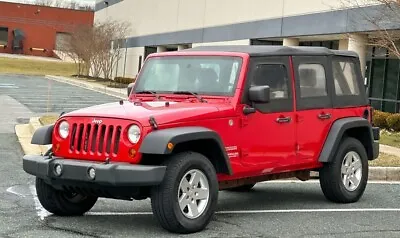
0;2;94;57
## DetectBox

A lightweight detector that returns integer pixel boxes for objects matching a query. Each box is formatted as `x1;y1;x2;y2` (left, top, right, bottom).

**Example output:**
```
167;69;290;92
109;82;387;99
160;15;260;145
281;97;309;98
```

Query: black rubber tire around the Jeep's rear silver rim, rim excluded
319;137;368;203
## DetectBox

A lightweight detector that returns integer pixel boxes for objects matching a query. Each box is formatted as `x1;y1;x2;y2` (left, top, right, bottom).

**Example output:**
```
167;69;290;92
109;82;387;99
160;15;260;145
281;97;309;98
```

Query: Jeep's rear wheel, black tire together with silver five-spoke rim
319;137;368;203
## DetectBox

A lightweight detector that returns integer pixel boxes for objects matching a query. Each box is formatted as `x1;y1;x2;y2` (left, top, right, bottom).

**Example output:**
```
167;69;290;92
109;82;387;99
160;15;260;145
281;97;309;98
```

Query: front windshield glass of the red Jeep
134;56;242;96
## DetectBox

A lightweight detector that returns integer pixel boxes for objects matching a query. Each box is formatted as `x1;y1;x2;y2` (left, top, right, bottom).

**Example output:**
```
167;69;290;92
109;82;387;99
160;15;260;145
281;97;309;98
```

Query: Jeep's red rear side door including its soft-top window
293;56;333;163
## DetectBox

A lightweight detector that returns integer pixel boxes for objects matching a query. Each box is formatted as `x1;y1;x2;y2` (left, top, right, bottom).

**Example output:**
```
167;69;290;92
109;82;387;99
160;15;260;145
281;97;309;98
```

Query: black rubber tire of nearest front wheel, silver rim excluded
151;152;218;234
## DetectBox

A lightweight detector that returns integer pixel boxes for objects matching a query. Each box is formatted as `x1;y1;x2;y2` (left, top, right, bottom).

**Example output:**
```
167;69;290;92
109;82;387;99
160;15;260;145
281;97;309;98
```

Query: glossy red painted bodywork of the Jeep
53;52;369;181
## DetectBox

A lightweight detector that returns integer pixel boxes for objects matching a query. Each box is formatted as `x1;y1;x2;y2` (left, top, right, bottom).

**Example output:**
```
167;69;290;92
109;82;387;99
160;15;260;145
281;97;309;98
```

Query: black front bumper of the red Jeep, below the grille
23;155;166;187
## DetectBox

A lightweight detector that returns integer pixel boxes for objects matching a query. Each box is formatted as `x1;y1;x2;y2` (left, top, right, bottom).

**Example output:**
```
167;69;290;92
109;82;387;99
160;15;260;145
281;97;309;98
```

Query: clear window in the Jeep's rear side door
298;64;328;98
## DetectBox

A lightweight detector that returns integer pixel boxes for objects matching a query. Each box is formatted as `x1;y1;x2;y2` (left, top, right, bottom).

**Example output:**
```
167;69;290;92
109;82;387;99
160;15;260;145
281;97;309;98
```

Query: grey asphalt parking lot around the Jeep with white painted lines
0;75;400;238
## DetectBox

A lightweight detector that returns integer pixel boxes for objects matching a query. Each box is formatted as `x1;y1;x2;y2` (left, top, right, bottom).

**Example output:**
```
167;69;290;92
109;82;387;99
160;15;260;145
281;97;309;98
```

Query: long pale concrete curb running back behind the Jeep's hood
45;75;127;99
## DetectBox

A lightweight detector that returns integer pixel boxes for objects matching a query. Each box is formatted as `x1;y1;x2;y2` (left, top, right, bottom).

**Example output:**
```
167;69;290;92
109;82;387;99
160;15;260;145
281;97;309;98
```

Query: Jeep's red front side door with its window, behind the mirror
240;57;296;169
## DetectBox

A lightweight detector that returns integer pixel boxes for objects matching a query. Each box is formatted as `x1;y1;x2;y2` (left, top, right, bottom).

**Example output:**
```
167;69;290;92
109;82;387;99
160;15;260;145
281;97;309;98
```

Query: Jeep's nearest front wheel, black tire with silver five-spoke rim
151;152;218;233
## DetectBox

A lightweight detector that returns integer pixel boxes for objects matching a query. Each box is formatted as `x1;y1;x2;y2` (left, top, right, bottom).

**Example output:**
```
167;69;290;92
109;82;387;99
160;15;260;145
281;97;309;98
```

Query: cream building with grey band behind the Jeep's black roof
95;0;400;112
